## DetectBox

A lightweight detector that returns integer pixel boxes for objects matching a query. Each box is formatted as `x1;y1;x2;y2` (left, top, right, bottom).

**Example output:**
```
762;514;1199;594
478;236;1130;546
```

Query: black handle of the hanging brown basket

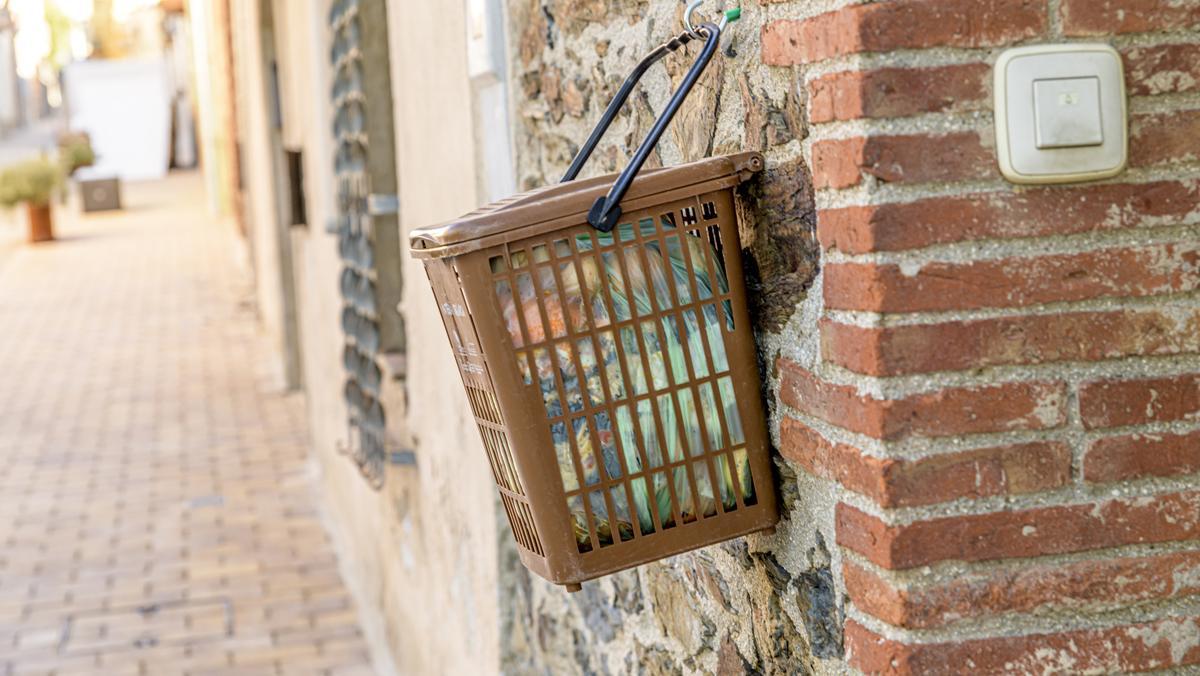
560;22;725;233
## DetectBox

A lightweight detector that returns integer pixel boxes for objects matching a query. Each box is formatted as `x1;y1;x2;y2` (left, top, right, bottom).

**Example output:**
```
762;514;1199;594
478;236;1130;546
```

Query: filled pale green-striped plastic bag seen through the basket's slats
492;217;755;551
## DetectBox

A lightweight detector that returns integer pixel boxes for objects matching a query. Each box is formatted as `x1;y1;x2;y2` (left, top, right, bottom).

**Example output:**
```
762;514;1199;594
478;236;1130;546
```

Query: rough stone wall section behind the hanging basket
500;0;844;674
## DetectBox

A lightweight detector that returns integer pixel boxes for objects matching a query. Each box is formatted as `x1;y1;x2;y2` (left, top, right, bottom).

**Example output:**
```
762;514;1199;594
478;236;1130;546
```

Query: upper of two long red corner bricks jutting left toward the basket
779;359;1067;439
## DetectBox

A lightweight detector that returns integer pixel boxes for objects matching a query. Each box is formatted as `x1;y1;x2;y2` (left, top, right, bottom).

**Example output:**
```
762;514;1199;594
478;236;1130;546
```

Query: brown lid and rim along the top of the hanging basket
408;151;766;258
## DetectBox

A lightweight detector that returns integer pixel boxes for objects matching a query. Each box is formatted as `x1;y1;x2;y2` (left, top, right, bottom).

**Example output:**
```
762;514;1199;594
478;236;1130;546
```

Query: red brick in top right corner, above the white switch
1060;0;1200;35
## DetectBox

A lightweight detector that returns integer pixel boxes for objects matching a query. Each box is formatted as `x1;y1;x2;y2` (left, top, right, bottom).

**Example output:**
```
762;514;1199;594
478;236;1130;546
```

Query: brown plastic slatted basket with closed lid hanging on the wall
410;26;779;590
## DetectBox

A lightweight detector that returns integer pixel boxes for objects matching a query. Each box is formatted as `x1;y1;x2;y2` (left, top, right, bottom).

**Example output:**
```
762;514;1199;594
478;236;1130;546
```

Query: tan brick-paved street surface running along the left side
0;174;371;676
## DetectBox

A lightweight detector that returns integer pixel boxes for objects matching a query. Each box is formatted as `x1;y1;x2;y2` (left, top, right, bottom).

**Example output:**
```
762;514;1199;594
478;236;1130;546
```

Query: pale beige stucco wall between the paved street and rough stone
236;0;499;674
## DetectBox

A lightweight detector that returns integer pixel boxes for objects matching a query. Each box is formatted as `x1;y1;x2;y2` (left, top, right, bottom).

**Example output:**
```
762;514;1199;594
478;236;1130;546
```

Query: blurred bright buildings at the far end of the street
0;0;197;169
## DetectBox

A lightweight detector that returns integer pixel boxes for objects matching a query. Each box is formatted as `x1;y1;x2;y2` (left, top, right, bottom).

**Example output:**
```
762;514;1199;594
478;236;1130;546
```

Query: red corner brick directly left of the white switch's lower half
812;132;1000;189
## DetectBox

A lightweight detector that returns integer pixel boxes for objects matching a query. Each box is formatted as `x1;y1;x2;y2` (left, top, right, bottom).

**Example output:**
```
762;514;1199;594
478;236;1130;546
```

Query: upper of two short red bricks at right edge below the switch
1079;373;1200;430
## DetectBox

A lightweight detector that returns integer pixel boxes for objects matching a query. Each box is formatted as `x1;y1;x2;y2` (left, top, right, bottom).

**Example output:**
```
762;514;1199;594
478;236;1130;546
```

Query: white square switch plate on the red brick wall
995;43;1129;184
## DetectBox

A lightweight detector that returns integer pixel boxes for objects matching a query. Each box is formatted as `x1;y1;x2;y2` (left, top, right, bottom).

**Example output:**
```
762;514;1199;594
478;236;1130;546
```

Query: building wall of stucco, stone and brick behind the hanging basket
191;0;1200;674
